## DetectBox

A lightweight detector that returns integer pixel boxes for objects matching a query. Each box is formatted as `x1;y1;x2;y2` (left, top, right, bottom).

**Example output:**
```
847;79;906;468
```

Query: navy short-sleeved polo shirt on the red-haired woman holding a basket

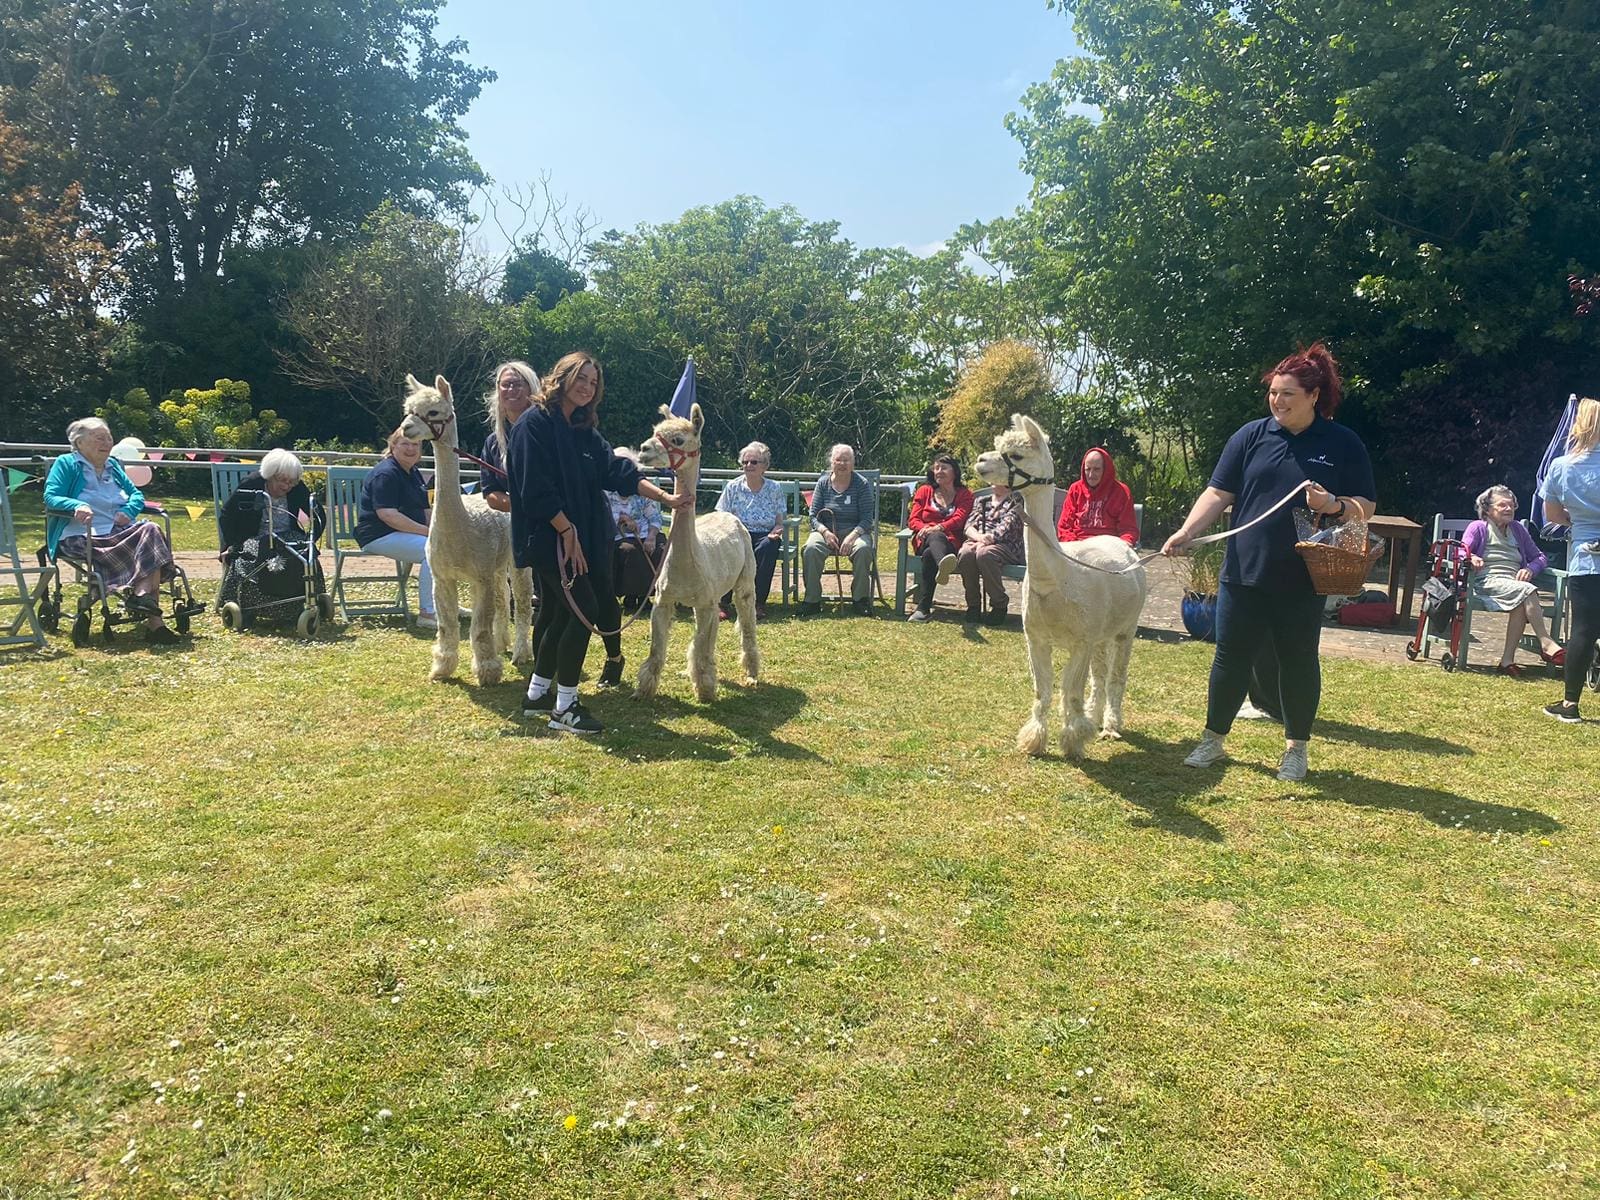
1211;416;1378;592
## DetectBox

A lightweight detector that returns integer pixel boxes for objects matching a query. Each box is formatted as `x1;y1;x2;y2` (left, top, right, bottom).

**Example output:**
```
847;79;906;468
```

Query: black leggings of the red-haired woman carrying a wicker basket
1205;582;1323;741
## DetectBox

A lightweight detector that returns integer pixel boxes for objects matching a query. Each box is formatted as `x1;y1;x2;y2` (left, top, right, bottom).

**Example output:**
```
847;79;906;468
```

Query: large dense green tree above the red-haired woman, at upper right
1010;0;1600;508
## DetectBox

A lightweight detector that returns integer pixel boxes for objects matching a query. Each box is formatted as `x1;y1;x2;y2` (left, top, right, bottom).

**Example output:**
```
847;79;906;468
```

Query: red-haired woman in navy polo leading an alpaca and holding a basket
1162;342;1378;782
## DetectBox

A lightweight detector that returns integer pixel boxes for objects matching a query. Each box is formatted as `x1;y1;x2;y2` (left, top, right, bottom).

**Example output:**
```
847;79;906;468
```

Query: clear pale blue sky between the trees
438;0;1075;251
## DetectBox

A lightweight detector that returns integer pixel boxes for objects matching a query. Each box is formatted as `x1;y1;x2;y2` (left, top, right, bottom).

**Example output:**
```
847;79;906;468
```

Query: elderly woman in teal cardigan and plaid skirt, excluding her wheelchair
45;416;178;643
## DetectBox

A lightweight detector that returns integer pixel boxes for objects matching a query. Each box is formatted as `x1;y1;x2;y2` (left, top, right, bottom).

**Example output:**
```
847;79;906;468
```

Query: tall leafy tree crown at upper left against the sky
0;0;494;304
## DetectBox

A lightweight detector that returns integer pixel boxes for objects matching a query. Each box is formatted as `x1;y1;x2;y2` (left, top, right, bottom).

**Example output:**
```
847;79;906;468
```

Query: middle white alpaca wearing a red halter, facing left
634;405;762;702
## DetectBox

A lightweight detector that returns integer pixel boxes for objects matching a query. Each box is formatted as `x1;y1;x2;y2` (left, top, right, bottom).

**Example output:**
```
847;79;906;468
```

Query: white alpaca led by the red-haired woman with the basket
978;414;1147;758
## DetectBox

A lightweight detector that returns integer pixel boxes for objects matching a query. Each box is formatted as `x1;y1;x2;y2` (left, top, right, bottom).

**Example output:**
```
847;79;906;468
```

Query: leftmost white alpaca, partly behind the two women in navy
400;374;533;686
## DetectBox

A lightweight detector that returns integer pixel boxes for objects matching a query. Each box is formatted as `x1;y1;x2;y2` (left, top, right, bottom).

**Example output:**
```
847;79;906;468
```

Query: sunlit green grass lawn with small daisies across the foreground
0;601;1600;1200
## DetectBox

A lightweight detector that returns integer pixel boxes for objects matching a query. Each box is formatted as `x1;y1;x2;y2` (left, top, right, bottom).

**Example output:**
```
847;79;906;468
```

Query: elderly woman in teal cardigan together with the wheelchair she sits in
45;416;202;646
